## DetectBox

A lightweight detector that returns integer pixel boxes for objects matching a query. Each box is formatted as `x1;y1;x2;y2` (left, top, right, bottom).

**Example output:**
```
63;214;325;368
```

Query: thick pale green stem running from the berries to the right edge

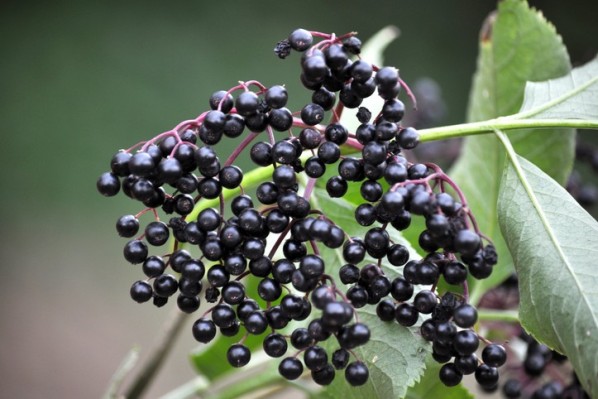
419;115;598;142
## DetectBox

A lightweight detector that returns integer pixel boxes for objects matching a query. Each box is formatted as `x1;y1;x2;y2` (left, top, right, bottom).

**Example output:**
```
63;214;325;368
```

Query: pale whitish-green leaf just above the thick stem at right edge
514;57;598;120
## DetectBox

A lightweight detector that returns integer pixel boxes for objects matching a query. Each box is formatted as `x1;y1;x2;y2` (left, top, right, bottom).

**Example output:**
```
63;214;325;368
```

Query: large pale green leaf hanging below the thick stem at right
499;141;598;397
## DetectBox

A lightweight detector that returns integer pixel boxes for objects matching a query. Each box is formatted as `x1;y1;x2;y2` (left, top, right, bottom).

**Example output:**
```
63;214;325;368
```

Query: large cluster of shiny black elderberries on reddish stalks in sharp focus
97;29;506;386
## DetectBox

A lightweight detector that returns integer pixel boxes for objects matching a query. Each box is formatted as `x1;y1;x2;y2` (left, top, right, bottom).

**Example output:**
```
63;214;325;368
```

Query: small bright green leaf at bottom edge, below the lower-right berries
405;357;473;399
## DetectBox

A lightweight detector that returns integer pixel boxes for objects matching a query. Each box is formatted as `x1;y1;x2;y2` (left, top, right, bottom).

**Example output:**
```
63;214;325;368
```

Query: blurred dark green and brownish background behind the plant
0;0;598;398
